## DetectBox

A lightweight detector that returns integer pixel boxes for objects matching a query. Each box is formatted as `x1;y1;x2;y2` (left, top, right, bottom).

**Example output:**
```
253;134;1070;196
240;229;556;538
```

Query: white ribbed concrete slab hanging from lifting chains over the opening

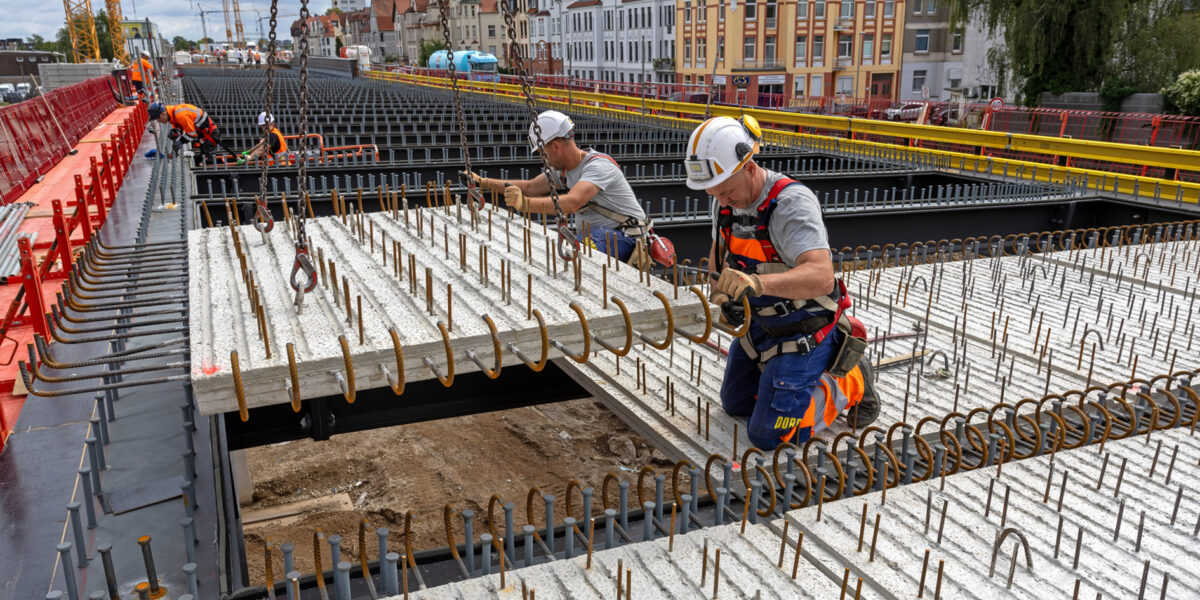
188;202;704;414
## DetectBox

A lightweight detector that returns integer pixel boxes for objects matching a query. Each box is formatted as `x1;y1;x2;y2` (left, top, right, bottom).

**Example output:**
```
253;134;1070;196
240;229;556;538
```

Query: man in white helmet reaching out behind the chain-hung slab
466;110;650;262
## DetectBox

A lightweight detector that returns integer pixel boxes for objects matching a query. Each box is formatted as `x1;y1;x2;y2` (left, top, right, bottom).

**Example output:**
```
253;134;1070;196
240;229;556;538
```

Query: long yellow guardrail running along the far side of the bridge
367;71;1200;204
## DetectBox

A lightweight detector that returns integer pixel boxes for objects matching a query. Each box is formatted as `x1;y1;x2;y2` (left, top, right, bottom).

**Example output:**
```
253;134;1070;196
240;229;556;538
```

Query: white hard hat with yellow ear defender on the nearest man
683;116;762;190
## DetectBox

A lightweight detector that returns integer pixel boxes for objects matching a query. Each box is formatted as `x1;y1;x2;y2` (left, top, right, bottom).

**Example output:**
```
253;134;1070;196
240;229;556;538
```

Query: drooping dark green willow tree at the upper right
952;0;1137;106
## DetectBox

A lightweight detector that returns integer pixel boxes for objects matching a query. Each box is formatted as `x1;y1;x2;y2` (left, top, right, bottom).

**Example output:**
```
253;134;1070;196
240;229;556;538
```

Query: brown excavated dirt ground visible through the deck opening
242;400;670;584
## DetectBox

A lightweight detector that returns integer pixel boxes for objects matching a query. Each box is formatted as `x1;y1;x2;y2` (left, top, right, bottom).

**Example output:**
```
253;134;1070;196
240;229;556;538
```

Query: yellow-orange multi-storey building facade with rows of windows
676;0;916;106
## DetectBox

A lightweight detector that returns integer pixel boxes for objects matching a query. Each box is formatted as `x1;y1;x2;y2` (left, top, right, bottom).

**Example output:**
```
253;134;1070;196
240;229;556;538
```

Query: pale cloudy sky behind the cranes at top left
0;0;332;40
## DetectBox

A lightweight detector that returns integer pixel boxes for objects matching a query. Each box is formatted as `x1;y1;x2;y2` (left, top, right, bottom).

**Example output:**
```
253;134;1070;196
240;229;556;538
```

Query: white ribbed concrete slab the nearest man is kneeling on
569;234;1200;462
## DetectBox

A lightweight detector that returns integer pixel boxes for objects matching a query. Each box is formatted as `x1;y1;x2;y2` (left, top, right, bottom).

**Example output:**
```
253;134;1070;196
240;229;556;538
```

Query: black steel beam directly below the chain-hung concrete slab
223;361;590;450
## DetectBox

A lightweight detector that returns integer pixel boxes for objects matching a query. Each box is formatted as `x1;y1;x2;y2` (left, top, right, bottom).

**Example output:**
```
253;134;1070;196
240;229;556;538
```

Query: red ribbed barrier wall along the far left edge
0;76;120;204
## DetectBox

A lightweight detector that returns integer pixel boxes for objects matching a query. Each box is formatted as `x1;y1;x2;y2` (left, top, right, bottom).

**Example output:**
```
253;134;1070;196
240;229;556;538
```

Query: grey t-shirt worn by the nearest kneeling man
712;167;829;266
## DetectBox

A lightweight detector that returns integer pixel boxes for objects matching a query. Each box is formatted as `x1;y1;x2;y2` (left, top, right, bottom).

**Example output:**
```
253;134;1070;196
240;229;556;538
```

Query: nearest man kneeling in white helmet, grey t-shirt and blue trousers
684;116;878;450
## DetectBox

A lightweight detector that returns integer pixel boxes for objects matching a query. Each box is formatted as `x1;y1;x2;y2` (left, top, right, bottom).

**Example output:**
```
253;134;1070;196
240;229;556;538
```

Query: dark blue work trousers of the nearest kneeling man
721;323;842;450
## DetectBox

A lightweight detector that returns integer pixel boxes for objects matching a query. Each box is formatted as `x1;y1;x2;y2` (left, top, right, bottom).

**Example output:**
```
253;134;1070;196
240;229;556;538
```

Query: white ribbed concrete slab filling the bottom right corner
770;428;1200;599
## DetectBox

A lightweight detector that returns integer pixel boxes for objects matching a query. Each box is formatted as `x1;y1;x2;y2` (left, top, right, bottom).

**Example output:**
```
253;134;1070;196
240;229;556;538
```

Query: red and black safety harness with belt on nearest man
716;178;851;366
